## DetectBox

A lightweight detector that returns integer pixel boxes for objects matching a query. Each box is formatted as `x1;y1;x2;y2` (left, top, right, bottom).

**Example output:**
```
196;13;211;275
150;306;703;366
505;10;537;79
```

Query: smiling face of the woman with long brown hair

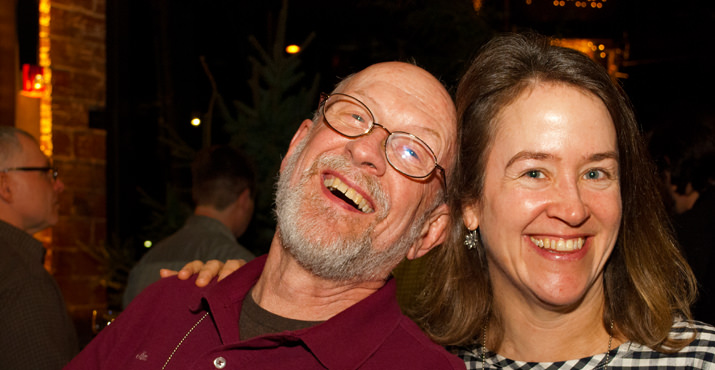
464;83;621;310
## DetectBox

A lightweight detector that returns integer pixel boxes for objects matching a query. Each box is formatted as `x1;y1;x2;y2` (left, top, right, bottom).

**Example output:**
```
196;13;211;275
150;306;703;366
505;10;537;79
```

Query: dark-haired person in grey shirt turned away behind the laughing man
123;145;256;307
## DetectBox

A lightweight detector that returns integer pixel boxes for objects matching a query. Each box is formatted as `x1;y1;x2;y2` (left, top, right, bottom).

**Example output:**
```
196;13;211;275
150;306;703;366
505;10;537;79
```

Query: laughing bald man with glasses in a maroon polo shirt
67;62;464;369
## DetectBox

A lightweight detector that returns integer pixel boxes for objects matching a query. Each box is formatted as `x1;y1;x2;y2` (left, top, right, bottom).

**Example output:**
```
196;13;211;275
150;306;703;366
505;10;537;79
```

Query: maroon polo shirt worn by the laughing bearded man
65;256;465;370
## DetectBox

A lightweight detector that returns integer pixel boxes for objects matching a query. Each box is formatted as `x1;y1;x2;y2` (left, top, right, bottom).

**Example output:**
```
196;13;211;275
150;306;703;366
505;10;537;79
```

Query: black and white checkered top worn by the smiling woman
456;321;715;370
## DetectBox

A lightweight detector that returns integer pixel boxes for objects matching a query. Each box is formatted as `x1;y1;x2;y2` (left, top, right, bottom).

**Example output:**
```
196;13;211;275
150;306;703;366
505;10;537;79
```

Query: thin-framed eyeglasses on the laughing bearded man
320;93;447;189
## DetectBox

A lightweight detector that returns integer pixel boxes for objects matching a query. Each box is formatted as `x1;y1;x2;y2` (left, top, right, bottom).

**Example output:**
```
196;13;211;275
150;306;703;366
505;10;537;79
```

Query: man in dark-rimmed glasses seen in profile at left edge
0;126;79;370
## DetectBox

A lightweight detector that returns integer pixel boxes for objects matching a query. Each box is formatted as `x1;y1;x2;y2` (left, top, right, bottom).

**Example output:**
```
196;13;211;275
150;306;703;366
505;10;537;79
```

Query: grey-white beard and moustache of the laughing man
276;140;428;282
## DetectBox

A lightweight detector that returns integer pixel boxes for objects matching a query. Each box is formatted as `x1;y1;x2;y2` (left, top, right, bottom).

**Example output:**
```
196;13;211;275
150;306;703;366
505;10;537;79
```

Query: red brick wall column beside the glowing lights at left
46;0;107;343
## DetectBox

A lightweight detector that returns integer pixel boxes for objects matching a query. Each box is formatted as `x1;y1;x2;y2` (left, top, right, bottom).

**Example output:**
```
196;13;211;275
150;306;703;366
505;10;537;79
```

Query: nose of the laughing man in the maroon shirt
345;126;389;176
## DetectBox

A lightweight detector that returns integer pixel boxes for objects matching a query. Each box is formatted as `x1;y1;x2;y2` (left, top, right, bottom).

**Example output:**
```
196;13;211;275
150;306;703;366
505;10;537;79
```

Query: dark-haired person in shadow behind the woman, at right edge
649;112;715;324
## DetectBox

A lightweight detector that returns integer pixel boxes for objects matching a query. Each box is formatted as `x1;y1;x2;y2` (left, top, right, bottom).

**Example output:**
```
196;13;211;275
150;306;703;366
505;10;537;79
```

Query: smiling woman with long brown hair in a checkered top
414;34;715;369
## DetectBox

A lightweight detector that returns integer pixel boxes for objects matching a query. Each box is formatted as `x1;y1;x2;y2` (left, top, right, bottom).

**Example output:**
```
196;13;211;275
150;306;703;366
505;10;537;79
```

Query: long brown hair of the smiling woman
411;33;696;352
